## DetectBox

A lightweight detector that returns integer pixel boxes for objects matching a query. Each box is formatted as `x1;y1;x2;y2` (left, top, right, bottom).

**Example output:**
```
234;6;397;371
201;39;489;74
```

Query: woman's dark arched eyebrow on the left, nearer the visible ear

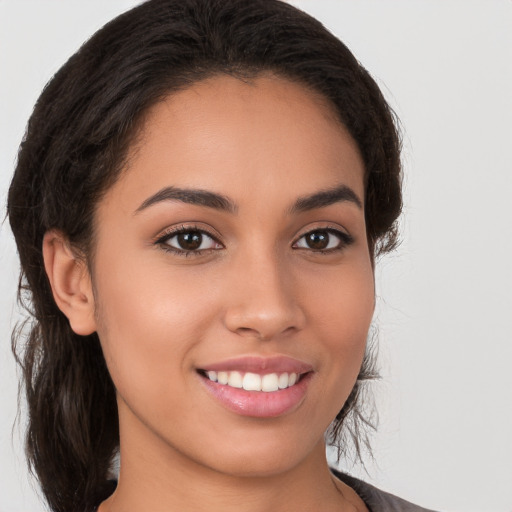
135;187;237;214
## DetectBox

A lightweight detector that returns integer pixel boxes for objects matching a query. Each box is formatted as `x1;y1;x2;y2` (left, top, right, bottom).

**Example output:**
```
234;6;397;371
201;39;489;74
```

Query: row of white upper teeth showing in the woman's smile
206;370;298;393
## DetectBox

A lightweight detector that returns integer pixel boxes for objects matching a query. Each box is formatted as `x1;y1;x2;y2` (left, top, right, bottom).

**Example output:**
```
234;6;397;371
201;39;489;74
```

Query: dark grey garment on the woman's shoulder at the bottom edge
331;469;440;512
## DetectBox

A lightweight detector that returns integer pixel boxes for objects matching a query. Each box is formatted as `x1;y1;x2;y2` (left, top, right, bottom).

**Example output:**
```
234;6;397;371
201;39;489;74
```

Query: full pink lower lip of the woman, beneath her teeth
200;373;312;418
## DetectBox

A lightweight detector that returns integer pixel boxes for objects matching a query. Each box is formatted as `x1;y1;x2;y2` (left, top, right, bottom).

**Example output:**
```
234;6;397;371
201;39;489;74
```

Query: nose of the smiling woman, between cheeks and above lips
224;254;305;341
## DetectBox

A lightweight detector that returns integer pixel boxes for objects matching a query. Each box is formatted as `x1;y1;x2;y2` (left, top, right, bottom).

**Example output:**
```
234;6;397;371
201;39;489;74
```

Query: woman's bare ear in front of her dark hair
43;230;96;336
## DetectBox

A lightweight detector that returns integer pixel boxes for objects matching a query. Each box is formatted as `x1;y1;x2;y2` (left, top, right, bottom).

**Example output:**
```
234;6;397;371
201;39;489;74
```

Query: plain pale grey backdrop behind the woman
0;0;512;512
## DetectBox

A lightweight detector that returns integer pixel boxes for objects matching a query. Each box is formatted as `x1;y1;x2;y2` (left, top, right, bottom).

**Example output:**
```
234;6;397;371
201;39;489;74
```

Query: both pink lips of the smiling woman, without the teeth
198;356;313;418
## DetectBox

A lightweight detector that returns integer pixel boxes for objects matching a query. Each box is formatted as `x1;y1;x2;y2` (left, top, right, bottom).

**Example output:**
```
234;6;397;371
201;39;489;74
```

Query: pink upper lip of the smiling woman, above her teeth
200;355;313;374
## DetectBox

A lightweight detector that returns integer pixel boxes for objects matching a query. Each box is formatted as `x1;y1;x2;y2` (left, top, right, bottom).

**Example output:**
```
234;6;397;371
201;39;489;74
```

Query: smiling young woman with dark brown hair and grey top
8;0;434;512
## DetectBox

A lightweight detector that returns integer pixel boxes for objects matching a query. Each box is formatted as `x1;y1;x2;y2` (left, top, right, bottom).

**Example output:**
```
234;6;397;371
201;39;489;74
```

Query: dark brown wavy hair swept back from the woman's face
8;0;401;512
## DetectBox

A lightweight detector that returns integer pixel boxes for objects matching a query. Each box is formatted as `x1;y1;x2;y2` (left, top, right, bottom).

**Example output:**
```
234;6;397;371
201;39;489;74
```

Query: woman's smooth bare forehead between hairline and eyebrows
103;76;364;212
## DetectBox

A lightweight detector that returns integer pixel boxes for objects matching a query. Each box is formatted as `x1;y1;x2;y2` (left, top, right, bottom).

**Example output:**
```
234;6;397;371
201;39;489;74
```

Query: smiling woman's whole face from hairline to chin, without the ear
92;76;374;475
